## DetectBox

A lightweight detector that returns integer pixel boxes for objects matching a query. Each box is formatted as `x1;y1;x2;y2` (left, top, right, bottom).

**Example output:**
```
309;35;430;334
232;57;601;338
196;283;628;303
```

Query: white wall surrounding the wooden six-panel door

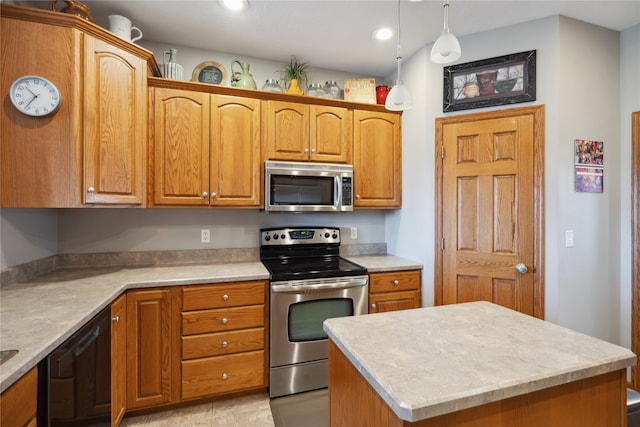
387;17;638;342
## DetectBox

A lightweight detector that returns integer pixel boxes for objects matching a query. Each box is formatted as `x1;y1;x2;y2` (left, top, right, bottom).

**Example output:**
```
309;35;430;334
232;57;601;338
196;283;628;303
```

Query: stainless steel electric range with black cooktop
260;227;369;397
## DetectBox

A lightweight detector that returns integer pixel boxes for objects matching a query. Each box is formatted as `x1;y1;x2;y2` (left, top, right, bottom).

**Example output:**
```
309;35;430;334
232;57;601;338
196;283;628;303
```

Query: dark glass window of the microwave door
270;175;334;206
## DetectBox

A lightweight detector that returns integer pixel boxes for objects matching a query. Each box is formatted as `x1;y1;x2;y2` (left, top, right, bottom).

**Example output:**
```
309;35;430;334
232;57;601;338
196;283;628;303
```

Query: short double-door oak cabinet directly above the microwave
263;100;353;163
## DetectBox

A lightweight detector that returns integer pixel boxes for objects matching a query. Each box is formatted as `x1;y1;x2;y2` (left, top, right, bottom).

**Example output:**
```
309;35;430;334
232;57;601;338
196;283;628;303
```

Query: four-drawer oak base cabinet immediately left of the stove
181;281;268;400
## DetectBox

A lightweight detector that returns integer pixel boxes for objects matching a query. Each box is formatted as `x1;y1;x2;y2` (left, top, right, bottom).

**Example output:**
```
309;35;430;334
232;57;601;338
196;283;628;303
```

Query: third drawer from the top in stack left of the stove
182;328;264;360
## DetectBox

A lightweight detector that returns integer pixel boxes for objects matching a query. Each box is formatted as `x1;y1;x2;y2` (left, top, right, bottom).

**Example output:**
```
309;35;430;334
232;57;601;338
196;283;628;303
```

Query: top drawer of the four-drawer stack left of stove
182;281;267;311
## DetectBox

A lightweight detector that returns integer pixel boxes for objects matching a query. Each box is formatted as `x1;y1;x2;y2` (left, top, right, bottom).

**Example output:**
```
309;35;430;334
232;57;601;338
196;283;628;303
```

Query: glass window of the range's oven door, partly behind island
287;298;353;342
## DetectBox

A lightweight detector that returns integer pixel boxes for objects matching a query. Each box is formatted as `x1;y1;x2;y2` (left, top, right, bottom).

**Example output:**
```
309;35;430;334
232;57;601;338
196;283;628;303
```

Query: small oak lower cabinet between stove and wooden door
369;270;422;313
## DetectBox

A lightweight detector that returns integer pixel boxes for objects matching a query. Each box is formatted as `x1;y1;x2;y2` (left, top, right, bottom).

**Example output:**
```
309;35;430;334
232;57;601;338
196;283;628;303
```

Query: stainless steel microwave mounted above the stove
264;161;353;212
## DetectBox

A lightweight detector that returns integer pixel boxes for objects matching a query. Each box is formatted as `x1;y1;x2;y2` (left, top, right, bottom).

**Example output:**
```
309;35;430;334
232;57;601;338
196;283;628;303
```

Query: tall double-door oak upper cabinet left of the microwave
151;88;262;207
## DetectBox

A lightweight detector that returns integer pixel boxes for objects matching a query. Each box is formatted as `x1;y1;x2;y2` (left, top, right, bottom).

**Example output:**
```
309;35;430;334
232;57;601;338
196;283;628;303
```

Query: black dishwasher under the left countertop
38;307;111;427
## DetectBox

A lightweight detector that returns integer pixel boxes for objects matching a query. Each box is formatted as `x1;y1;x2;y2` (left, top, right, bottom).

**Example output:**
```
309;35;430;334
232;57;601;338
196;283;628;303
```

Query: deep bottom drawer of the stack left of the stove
182;351;266;399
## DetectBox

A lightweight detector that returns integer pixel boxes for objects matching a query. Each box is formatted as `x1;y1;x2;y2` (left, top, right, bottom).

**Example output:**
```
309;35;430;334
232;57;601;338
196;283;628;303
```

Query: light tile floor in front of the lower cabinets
120;393;275;427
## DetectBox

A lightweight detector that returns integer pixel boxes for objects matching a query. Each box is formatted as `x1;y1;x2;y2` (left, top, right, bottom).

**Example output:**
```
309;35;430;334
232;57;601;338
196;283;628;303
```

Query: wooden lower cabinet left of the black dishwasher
0;367;38;427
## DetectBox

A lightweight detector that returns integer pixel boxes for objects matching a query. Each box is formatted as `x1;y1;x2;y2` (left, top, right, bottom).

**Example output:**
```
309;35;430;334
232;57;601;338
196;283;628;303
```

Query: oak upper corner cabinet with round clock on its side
0;3;159;208
